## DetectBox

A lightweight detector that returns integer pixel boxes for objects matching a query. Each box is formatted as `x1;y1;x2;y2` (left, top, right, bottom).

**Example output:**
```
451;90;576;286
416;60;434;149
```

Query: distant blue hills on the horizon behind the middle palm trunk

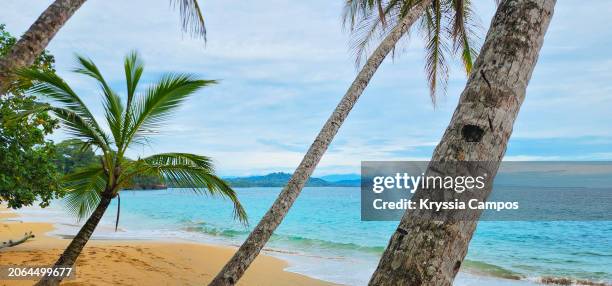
225;172;360;188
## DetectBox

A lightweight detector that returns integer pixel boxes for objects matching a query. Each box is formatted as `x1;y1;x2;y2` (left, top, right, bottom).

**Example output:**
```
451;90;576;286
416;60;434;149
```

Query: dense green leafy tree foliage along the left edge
0;24;63;208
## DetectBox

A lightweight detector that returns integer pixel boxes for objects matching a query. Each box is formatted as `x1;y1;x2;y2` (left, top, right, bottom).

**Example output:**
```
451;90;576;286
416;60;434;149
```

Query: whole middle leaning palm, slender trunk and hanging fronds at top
209;0;482;286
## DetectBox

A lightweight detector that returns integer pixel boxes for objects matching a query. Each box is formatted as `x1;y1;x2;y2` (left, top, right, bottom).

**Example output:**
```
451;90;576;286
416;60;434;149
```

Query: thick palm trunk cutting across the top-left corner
0;0;86;95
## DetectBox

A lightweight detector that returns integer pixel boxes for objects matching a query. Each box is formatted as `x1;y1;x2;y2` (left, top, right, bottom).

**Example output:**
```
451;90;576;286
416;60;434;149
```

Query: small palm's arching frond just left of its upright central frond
74;56;124;145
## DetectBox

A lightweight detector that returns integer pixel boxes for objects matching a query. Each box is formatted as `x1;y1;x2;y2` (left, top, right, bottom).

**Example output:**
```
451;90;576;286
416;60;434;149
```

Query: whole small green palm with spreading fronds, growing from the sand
18;53;246;285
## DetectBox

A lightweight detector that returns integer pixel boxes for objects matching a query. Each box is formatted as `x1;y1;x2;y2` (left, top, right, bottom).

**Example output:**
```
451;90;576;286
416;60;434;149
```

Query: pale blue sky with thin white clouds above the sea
0;0;612;176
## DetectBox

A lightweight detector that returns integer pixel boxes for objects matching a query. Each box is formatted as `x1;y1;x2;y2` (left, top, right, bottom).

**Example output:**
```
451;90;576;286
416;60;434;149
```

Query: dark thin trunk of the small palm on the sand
36;194;111;286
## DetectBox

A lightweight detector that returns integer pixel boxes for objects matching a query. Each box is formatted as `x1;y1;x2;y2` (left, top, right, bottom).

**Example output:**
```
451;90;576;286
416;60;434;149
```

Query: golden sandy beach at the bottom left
0;207;331;285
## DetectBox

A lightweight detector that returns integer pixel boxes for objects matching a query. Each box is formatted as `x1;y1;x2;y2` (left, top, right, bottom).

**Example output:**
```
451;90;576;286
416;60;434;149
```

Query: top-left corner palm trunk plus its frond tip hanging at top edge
0;0;206;95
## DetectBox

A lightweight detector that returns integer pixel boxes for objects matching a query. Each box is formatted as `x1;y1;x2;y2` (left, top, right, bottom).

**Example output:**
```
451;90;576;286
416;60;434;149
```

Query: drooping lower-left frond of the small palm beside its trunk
62;166;107;220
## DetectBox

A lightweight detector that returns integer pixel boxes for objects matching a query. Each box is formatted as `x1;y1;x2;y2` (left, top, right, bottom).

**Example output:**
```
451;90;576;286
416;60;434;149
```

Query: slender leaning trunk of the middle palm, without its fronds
209;0;431;286
